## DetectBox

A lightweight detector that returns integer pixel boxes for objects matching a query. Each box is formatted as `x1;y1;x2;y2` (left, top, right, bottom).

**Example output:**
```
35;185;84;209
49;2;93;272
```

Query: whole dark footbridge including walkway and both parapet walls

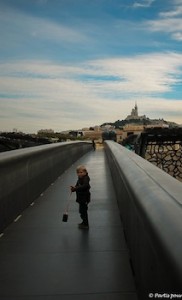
0;141;182;300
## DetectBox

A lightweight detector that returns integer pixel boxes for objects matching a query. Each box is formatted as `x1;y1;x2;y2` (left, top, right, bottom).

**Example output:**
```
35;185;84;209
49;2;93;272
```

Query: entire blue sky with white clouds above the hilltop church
0;0;182;133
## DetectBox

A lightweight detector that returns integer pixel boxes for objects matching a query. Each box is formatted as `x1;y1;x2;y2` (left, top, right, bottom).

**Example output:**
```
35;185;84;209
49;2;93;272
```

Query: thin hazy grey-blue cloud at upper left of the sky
0;4;87;48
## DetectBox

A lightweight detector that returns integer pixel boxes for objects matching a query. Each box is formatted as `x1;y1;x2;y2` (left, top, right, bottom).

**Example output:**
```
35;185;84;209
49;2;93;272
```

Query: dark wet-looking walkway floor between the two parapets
0;150;137;300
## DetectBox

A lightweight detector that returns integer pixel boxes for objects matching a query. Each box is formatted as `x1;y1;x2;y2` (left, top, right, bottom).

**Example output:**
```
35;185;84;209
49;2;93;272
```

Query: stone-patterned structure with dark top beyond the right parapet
135;128;182;181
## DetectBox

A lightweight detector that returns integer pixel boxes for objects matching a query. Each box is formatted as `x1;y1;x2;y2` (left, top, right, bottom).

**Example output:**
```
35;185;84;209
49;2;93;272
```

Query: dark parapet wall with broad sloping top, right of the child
105;141;182;300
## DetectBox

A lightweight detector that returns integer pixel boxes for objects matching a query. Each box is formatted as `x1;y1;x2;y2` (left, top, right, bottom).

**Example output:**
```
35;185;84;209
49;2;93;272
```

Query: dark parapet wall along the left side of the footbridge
0;142;92;233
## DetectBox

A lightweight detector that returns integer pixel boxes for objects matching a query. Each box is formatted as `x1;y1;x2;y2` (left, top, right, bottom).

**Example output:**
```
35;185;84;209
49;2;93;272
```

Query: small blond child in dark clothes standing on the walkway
70;166;91;229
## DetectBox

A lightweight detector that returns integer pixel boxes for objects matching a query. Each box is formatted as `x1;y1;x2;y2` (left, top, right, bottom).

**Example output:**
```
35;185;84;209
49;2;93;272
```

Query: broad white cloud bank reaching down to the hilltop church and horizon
0;53;182;132
